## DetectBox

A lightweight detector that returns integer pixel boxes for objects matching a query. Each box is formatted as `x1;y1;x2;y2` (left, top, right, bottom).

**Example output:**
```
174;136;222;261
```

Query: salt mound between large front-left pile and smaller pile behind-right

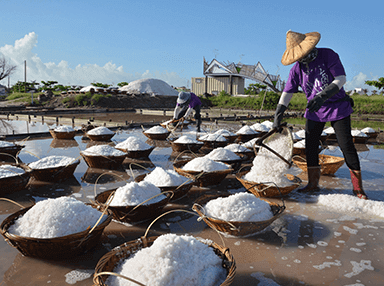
110;181;166;207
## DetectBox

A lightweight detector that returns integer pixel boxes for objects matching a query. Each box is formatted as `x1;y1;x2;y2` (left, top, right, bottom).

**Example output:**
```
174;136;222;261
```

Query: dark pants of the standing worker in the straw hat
305;116;360;170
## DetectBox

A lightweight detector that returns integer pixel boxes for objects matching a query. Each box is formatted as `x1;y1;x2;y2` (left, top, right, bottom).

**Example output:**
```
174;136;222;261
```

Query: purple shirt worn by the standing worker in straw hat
284;48;353;122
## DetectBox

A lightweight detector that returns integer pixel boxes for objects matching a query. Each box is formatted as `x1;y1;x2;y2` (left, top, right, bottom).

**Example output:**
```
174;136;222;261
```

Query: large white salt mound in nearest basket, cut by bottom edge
106;234;226;286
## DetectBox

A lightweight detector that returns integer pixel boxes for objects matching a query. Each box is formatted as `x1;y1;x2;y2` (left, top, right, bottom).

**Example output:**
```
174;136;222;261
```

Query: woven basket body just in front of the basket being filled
192;195;285;237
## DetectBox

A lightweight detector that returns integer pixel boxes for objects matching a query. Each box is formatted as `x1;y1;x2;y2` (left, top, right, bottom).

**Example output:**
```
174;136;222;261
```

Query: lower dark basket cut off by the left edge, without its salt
0;164;31;196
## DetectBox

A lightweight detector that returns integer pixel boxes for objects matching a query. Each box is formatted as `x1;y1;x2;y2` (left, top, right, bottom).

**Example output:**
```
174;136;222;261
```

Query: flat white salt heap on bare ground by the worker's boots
317;194;384;217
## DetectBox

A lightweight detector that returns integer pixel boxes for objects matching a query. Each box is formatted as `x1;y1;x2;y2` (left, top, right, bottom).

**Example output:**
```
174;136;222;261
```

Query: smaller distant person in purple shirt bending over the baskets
173;91;201;132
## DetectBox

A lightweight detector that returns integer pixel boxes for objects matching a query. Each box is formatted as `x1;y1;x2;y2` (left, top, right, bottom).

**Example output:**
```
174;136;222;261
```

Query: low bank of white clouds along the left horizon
0;32;187;86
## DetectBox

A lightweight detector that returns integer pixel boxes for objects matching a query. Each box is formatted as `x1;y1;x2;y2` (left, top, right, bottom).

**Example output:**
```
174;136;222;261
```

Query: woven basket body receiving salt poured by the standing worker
236;171;301;198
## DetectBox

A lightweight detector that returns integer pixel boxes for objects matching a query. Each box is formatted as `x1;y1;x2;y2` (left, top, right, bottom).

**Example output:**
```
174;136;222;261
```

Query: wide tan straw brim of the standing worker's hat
281;32;320;66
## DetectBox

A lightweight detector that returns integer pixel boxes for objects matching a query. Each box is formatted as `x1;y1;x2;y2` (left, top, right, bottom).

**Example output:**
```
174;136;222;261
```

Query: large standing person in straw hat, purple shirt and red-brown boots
274;31;367;199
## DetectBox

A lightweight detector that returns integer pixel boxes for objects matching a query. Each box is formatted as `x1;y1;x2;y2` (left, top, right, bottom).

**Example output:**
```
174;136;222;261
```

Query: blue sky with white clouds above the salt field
0;0;384;90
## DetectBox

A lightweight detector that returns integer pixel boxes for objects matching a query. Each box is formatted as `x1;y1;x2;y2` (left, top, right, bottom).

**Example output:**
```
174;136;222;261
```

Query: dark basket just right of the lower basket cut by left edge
31;160;80;182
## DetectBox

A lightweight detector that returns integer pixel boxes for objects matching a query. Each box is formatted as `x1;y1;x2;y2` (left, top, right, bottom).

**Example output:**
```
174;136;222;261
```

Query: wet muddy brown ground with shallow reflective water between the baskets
0;116;384;286
